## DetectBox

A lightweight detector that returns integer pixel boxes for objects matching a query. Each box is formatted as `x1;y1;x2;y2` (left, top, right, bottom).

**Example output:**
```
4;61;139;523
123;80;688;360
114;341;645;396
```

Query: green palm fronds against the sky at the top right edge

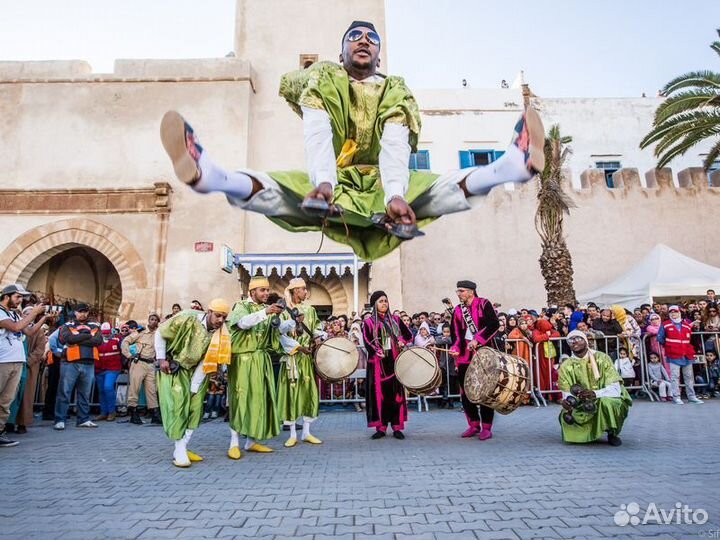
640;30;720;171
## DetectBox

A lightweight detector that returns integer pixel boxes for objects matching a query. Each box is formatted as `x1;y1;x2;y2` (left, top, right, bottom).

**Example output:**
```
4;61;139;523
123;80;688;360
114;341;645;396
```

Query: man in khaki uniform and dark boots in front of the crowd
121;313;162;425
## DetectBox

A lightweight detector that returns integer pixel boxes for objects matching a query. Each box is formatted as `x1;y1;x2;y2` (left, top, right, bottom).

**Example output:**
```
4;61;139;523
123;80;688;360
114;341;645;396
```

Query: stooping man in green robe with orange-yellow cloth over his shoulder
155;298;231;467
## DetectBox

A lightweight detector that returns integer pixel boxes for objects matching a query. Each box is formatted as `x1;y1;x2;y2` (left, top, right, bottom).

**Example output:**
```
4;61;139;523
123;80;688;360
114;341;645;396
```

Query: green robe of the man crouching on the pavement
558;351;632;443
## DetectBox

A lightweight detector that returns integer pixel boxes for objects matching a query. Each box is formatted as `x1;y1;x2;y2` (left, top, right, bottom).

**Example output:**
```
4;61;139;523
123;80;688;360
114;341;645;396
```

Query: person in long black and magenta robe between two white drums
363;291;413;439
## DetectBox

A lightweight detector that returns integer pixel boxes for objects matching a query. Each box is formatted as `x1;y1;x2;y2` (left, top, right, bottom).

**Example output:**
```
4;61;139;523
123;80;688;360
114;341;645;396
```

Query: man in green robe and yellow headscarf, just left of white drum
278;278;327;448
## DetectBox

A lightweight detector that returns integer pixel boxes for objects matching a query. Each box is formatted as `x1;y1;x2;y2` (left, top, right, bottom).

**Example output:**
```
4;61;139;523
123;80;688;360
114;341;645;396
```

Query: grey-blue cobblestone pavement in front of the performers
0;400;720;540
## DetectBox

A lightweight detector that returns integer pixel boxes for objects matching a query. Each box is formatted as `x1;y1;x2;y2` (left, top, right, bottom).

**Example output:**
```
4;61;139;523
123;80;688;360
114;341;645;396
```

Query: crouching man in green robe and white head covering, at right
558;330;632;446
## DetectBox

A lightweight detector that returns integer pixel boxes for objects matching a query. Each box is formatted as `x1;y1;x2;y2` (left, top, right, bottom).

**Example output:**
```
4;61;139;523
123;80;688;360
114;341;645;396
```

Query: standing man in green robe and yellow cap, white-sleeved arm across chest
227;276;283;459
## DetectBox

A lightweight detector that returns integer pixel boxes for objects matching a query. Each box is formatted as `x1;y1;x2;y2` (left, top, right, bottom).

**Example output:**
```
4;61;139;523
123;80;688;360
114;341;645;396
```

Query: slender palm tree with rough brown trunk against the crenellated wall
535;124;575;306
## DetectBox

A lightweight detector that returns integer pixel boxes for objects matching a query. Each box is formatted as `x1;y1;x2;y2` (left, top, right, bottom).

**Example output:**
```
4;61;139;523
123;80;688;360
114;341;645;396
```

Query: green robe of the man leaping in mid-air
268;62;438;261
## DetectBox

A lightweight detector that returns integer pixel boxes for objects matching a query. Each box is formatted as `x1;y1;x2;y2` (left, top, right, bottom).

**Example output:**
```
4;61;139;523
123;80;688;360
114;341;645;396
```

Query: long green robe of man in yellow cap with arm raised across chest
227;300;280;441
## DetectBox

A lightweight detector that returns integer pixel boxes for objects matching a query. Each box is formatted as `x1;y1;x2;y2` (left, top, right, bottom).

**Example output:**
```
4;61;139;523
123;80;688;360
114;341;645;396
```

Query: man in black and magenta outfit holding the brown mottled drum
450;280;500;441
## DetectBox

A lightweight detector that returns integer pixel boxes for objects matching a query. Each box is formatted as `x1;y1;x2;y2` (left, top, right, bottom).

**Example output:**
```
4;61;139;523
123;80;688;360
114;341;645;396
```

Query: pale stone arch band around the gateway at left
0;219;154;319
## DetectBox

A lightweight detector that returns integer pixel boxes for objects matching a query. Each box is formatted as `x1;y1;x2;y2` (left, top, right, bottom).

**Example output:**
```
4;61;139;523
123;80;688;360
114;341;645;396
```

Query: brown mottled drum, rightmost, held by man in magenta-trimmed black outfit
463;347;530;414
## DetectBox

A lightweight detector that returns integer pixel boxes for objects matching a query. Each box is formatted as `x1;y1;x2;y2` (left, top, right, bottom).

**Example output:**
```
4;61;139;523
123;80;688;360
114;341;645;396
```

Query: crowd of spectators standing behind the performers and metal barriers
0;285;720;447
